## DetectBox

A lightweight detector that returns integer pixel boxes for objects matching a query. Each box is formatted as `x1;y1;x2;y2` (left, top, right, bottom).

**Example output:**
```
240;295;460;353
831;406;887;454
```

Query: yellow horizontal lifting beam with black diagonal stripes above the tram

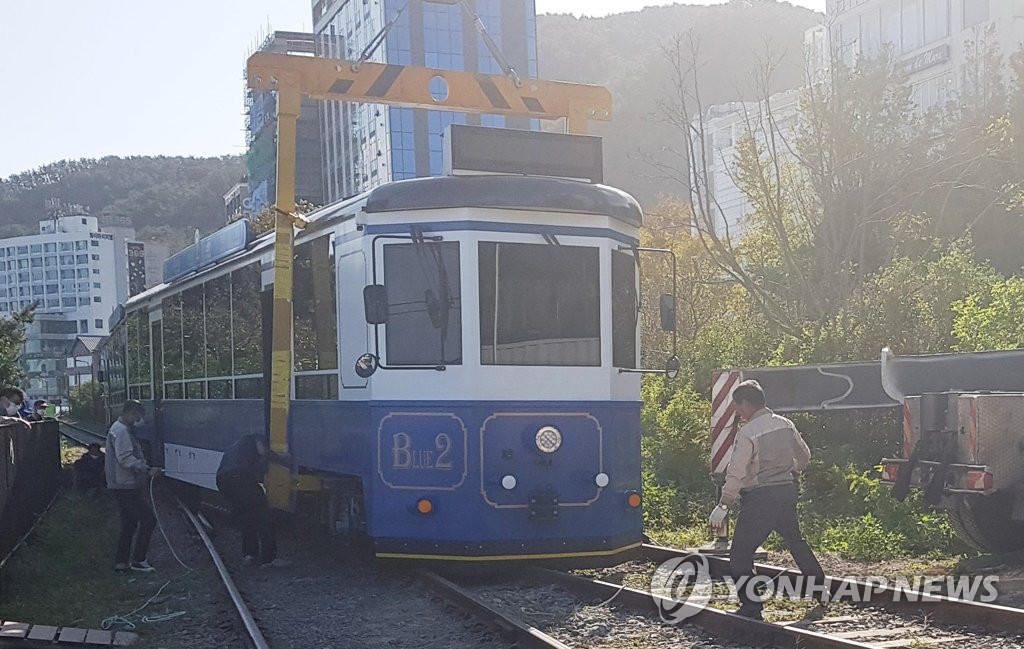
248;52;611;133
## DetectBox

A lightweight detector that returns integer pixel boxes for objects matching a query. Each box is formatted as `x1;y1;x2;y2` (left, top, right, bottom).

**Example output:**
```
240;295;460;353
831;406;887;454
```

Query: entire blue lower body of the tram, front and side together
151;400;643;560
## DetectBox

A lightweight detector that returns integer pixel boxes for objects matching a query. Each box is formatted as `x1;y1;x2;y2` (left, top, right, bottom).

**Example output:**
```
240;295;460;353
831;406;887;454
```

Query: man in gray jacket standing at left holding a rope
103;400;160;572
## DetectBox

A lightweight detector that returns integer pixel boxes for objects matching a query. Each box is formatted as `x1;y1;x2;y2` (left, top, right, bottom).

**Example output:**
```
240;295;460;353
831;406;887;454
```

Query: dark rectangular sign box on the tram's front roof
444;124;604;183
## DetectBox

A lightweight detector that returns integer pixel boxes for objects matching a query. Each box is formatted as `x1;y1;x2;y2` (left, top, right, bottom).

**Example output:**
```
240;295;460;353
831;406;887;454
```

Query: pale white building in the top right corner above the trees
826;0;1024;113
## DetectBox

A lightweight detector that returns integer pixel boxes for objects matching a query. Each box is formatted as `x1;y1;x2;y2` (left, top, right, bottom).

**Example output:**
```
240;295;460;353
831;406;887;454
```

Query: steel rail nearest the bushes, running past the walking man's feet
642;544;1024;634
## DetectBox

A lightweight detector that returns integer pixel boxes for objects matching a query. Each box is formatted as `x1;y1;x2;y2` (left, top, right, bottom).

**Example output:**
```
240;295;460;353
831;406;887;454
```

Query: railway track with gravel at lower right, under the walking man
422;546;1024;649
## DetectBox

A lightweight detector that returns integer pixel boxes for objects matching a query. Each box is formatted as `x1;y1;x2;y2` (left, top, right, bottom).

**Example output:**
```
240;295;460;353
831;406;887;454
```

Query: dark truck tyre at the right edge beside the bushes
949;491;1024;554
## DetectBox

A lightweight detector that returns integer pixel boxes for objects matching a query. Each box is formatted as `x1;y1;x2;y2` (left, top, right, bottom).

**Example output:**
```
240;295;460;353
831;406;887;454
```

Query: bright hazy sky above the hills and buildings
0;0;824;177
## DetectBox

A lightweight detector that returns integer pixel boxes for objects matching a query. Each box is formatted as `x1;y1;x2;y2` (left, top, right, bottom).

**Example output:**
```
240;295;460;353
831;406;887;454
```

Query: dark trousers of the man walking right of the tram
729;483;824;610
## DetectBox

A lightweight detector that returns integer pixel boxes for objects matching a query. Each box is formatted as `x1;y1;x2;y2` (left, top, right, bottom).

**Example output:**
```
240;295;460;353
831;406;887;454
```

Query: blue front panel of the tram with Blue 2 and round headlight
365;402;643;559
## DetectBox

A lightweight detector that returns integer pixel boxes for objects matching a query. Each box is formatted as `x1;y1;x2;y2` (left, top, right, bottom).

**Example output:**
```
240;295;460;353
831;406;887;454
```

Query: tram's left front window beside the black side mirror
384;242;462;365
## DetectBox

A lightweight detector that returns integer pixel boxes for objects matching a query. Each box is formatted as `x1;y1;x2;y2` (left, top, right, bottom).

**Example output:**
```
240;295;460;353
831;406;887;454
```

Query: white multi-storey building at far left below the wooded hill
0;214;128;400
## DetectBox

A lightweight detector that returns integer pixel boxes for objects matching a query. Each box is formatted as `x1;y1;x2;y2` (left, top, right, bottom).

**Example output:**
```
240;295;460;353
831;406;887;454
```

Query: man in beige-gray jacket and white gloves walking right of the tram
709;381;824;619
